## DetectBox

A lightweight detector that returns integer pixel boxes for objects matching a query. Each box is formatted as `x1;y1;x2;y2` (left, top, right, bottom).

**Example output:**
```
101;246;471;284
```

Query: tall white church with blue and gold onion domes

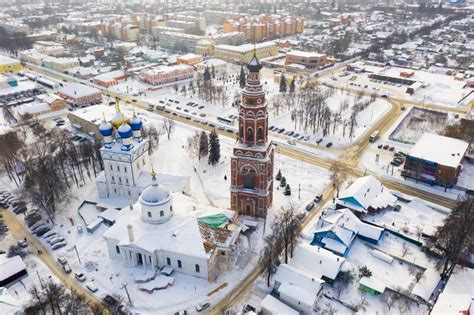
96;102;151;202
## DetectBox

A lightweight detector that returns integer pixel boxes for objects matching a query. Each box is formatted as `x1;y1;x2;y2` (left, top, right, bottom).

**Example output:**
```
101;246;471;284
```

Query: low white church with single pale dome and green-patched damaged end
104;171;240;281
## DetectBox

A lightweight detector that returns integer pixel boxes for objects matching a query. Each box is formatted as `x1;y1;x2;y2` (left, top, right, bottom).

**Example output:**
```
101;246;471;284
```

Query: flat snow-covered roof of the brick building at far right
409;133;469;168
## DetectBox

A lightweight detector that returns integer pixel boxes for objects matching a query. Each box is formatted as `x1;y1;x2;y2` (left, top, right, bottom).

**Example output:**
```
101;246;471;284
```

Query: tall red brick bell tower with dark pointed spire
230;50;273;218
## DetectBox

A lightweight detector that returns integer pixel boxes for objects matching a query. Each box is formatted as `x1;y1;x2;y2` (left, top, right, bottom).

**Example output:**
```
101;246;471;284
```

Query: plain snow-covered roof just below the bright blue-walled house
291;243;345;279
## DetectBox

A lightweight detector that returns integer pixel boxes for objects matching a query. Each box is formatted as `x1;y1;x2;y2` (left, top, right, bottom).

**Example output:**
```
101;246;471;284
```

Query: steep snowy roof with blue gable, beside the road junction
338;175;397;211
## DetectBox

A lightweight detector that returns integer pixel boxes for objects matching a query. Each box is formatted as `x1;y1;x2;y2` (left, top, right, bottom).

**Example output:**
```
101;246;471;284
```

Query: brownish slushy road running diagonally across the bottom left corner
0;208;106;313
